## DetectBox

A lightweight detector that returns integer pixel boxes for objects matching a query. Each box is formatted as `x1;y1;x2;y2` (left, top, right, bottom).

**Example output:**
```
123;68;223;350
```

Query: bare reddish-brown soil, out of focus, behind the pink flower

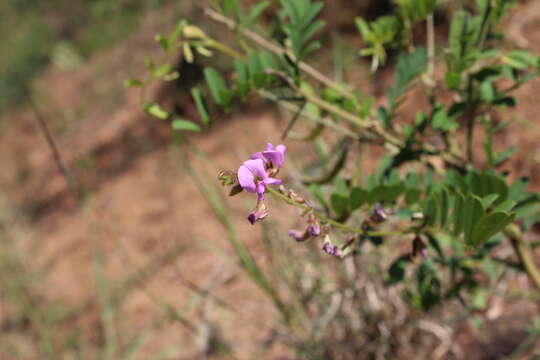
0;2;540;359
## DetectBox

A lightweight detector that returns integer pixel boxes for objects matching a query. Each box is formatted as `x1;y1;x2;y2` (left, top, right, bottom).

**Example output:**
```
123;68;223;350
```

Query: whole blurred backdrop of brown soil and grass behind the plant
0;0;540;360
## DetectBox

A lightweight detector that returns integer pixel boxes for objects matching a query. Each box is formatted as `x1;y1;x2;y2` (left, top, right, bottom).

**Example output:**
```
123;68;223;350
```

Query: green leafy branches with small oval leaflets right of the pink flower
136;0;540;330
